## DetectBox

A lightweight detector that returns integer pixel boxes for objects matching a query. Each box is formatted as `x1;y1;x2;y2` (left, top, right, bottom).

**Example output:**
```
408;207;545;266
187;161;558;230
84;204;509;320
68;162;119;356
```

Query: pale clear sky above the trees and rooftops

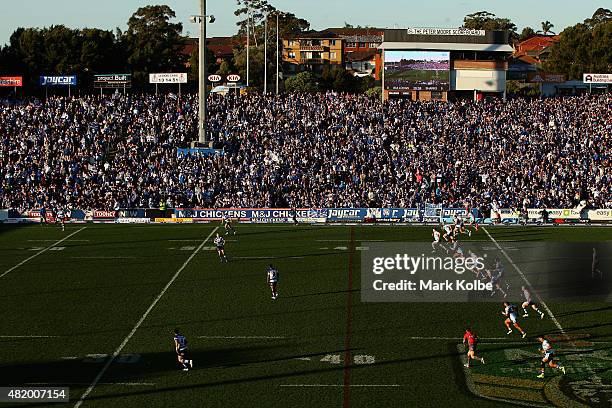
0;0;610;44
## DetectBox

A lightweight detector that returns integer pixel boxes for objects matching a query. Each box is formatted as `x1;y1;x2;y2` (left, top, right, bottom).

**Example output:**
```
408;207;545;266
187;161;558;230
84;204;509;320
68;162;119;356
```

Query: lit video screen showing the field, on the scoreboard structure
385;51;450;91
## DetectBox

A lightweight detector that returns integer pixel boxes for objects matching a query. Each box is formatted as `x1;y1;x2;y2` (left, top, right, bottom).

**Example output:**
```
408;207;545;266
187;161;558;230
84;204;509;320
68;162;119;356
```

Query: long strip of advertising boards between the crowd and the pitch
0;209;612;224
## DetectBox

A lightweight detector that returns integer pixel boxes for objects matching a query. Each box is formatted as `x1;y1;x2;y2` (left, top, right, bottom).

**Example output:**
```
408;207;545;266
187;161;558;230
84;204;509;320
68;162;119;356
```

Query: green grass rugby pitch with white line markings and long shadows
0;224;612;408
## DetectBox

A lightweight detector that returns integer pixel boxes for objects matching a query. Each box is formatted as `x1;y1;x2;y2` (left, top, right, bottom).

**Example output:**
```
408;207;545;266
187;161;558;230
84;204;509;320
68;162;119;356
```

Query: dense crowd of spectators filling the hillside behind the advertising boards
0;93;612;210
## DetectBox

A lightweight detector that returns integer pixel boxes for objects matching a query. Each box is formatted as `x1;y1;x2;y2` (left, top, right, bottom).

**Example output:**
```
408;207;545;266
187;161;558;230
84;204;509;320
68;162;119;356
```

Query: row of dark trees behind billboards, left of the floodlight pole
0;6;186;92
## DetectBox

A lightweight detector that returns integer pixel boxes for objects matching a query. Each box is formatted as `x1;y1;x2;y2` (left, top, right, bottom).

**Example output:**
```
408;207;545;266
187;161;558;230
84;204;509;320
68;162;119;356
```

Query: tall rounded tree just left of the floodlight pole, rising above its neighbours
122;5;186;84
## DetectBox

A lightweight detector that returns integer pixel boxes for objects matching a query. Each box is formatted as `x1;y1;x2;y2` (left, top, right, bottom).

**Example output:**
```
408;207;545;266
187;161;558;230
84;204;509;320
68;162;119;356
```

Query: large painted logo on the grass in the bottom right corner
457;334;612;408
